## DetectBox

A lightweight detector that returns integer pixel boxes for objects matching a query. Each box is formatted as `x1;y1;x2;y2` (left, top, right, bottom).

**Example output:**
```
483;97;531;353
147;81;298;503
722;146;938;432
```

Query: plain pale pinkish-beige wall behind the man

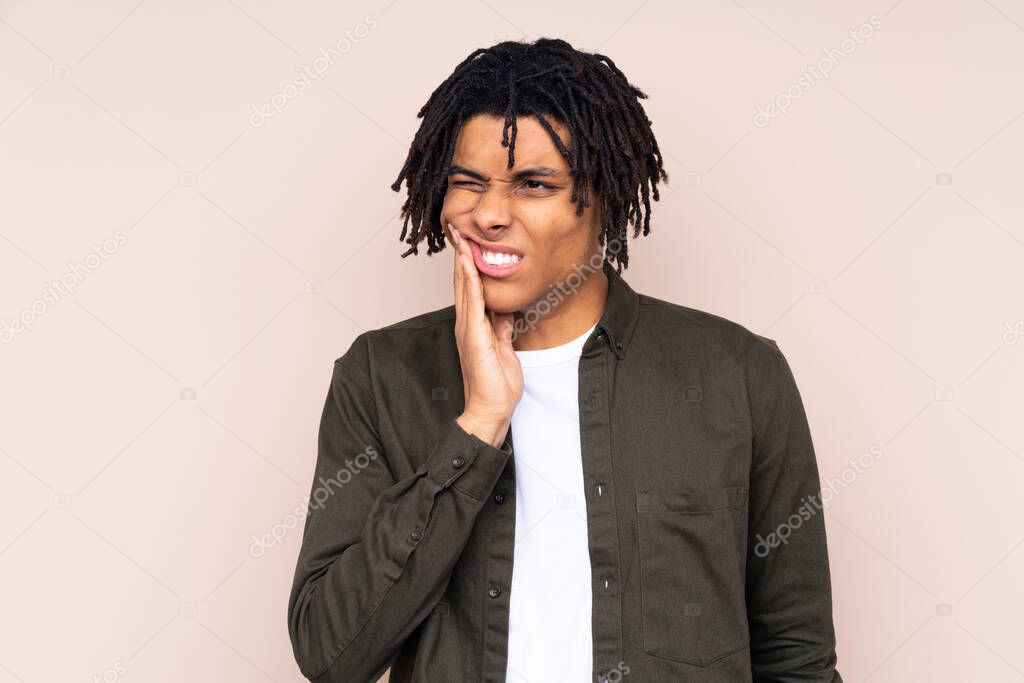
0;0;1024;683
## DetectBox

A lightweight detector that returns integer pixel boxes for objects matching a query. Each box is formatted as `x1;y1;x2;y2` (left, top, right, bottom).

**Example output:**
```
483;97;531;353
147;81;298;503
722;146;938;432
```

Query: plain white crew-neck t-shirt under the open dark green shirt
505;325;597;683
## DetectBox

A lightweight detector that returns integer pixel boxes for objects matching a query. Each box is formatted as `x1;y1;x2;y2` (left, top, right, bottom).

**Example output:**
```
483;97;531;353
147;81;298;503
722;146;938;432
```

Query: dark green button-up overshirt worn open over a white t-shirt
288;259;842;683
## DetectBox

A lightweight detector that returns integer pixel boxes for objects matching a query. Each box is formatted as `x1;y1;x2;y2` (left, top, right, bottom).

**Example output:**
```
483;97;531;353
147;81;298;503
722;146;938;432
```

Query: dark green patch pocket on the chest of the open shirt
636;486;750;667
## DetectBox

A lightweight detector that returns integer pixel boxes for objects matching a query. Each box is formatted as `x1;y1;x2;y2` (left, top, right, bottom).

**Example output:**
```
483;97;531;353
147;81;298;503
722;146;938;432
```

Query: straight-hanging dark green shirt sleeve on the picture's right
746;336;843;683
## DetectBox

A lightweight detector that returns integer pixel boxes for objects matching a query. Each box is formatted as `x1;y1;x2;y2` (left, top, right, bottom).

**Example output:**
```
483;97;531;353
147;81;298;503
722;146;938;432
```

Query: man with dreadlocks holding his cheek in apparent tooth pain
288;39;842;683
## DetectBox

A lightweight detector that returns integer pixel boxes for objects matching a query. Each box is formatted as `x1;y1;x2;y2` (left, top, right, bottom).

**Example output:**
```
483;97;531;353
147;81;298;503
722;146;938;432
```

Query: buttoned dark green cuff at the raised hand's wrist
426;418;512;503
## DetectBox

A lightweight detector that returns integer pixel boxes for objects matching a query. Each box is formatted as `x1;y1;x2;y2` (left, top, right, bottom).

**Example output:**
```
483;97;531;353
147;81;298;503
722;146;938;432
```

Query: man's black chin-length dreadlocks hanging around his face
391;38;669;272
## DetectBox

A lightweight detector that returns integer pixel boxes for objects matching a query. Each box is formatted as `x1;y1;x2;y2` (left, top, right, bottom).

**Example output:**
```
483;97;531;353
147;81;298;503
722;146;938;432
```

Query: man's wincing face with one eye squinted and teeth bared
441;115;600;312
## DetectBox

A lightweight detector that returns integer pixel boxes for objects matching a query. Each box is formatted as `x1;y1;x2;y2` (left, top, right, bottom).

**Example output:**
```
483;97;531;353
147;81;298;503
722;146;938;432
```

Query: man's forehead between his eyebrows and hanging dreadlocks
452;114;570;176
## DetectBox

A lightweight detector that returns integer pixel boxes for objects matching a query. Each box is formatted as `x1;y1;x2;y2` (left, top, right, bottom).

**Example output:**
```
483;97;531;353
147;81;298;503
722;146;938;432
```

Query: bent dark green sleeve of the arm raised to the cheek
288;345;511;683
